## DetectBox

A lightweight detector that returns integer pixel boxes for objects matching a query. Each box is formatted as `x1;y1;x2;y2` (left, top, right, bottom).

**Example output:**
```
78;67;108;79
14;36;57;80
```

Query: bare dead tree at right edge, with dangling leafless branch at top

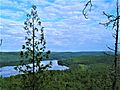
83;0;120;90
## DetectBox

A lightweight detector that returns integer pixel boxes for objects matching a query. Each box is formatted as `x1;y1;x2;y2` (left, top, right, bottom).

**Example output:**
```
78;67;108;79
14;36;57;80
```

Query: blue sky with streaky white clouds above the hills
0;0;120;52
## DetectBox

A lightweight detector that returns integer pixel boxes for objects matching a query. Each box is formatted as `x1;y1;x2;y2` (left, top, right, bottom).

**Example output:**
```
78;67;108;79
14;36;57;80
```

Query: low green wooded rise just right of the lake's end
59;55;119;67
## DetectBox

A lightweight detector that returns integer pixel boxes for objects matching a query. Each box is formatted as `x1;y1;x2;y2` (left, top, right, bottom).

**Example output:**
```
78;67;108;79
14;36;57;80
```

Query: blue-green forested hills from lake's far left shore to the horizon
0;51;116;66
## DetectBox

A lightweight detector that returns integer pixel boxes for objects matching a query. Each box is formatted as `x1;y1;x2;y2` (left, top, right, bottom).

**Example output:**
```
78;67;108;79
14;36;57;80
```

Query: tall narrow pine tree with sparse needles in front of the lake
15;5;51;90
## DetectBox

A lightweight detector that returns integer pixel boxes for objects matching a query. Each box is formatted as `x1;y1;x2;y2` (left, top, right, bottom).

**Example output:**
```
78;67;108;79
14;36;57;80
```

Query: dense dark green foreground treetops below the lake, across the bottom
0;64;120;90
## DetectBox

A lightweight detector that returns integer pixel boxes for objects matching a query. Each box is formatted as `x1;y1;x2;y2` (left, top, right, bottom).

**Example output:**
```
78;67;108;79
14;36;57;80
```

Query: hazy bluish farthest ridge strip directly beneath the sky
0;51;104;61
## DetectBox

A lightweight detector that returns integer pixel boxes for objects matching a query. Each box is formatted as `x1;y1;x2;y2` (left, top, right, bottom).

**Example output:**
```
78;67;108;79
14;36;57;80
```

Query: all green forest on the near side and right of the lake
0;55;120;90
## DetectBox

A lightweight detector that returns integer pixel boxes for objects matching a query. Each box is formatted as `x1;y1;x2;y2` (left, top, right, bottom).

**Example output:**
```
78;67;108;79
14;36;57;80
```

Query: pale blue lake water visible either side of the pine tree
0;60;69;77
